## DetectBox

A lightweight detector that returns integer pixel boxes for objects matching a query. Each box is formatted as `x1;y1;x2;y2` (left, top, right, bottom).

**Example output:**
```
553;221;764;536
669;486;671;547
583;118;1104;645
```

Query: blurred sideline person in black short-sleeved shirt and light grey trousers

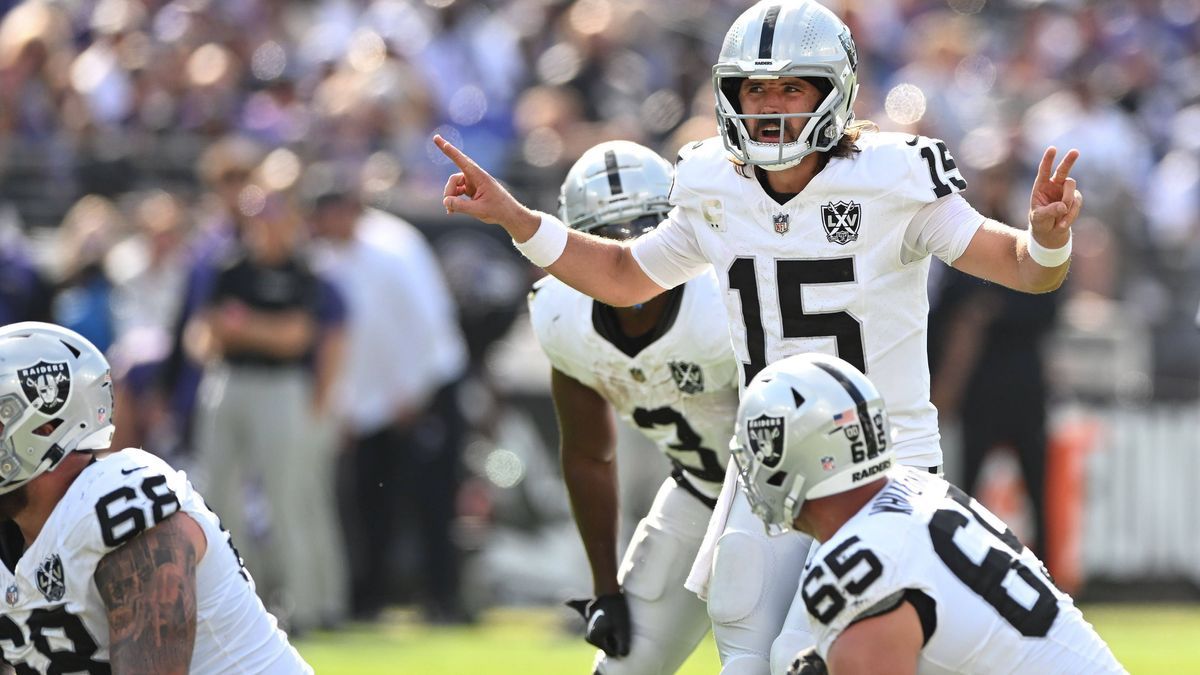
186;183;331;632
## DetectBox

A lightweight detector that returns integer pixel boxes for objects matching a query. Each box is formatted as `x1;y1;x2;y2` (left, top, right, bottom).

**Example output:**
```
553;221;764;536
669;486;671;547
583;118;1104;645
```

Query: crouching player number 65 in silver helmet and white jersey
733;354;1124;675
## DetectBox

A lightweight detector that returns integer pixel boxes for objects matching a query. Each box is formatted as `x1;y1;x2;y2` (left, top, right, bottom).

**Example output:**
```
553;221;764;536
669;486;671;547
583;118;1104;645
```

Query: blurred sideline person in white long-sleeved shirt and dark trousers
306;165;469;622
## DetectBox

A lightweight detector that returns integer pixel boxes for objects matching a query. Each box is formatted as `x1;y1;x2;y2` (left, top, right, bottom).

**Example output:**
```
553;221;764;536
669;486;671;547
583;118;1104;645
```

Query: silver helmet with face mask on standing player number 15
713;0;858;171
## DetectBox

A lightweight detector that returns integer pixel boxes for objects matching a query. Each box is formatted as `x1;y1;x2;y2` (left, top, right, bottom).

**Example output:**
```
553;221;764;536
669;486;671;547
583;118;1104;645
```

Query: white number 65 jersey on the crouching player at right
800;466;1124;674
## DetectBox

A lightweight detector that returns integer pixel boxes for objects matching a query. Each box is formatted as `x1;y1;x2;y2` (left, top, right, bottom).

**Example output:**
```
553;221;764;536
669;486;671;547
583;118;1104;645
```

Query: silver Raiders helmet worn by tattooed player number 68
0;322;114;494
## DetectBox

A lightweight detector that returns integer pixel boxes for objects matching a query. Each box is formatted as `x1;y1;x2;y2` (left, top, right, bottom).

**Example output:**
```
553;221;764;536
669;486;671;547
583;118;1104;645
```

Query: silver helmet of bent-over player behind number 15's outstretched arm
558;141;674;239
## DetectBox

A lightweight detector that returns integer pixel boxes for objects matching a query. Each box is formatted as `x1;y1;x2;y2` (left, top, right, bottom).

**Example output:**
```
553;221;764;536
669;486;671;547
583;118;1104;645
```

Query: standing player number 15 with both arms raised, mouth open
434;0;1082;675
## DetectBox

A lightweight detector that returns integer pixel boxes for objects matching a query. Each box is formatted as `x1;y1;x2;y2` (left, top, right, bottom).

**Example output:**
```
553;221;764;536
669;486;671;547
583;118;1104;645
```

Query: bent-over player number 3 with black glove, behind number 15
540;141;806;675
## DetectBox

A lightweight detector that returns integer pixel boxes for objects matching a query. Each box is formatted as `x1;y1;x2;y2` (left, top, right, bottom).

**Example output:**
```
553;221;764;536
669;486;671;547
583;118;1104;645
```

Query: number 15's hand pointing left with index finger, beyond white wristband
433;136;540;234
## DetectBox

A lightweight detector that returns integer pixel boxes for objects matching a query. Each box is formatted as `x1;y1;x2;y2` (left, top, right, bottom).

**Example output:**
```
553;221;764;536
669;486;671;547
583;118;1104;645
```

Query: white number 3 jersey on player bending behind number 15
529;267;738;497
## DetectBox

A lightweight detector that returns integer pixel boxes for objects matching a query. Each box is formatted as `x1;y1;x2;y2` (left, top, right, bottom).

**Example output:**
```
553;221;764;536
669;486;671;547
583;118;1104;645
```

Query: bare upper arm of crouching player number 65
826;602;925;675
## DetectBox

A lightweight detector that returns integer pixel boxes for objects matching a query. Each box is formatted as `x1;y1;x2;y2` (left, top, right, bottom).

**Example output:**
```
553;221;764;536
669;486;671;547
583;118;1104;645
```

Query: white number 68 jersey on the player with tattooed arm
0;448;312;675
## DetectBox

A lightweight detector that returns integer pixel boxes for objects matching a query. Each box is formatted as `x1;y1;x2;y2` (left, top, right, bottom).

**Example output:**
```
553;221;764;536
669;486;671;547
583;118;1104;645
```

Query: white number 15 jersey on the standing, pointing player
632;133;983;466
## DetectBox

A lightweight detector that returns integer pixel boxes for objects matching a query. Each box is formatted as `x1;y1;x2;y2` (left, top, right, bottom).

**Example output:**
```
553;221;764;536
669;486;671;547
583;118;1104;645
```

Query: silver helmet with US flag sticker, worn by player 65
730;353;895;534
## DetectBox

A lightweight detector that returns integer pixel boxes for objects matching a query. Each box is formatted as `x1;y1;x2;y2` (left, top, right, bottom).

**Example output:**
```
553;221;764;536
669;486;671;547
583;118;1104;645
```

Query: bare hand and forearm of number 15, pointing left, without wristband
433;136;664;307
